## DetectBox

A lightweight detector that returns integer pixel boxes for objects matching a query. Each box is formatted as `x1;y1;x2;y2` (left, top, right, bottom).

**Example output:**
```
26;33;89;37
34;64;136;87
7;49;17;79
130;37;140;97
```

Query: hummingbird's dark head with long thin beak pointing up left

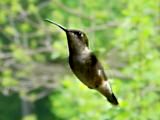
46;19;88;53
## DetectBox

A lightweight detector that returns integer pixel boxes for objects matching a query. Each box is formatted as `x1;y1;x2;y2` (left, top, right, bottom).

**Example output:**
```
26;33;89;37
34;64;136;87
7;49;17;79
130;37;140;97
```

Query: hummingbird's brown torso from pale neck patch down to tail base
69;48;103;89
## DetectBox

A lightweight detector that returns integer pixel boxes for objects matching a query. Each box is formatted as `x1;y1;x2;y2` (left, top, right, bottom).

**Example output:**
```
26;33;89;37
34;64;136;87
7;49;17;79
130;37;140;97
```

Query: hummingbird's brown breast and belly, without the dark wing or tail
69;52;100;88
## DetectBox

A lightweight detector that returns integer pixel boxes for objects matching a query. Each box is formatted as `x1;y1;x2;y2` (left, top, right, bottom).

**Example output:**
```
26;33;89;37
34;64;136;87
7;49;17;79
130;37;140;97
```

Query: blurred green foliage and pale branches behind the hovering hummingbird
0;0;160;120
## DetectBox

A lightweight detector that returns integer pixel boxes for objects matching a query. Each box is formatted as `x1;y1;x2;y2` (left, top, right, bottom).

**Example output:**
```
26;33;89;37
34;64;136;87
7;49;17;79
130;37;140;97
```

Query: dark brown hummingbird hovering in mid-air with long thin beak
45;19;118;105
